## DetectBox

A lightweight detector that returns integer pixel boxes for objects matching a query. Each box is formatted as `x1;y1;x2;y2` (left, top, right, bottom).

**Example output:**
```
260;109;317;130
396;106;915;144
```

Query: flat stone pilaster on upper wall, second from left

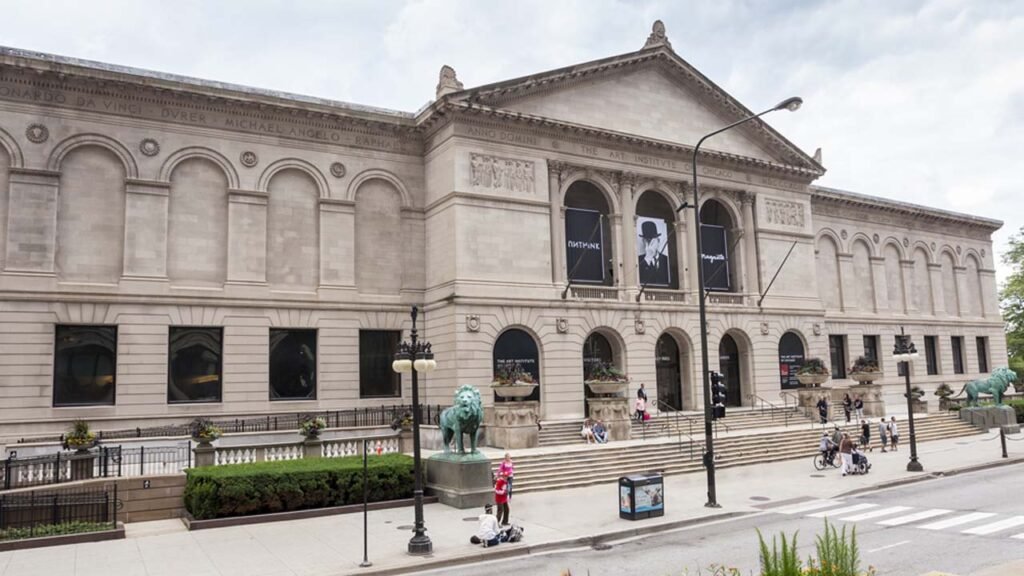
124;180;171;280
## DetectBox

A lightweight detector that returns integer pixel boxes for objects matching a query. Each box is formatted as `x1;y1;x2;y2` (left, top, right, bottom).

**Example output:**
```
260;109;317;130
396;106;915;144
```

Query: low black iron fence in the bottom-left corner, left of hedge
0;484;119;540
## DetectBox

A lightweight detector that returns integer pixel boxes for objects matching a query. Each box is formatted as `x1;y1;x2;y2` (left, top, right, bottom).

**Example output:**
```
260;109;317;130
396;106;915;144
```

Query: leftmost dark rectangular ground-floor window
53;326;118;407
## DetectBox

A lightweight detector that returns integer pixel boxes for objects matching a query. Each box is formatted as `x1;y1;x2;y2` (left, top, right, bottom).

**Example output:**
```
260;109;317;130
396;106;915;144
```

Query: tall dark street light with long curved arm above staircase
692;96;804;508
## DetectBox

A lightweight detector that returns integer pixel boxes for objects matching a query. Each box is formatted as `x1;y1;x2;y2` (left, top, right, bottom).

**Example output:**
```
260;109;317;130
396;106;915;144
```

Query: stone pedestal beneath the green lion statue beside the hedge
424;452;495;509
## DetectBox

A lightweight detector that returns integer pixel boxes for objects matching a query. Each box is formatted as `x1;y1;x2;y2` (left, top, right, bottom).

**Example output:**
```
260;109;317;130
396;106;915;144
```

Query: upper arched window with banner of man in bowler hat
636;191;679;289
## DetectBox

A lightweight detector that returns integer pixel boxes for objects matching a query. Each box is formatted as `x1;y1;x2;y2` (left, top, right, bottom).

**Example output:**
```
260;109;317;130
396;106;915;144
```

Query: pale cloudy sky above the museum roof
0;0;1024;280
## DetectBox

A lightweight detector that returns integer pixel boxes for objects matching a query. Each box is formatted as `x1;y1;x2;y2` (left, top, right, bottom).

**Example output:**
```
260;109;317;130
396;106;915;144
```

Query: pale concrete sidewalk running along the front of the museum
0;433;1024;576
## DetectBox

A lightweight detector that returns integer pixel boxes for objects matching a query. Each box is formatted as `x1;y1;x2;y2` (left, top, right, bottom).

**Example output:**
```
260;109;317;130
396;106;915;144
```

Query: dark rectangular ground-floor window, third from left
270;328;316;400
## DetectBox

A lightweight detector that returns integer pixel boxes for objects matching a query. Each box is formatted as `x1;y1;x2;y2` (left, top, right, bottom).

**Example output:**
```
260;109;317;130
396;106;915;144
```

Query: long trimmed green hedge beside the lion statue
184;454;414;520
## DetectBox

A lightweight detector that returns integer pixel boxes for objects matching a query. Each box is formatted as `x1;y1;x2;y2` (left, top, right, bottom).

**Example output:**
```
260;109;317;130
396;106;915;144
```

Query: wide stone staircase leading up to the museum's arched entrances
495;413;981;493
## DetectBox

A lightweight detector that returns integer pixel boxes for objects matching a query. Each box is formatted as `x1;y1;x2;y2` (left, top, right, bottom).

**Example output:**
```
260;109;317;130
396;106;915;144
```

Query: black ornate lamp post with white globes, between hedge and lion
391;306;437;556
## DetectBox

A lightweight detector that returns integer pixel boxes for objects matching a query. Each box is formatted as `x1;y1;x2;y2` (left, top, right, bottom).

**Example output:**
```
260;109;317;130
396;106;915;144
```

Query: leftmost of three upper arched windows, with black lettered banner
565;180;615;286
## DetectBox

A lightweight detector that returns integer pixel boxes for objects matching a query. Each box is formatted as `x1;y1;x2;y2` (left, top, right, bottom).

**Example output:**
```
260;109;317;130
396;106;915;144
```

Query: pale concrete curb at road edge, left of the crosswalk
344;511;758;576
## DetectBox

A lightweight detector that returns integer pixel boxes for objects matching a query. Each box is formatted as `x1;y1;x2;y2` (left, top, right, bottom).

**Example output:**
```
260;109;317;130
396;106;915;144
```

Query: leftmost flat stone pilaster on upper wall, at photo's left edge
4;168;60;276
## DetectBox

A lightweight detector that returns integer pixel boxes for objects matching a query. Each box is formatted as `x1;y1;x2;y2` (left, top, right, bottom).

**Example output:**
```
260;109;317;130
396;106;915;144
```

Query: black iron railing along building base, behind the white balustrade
17;404;444;444
